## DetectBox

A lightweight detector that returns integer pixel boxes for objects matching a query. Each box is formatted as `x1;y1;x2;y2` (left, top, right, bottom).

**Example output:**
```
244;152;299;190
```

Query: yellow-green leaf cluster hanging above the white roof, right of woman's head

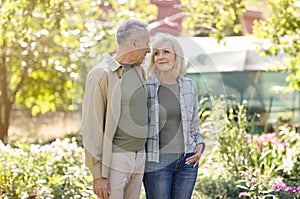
181;0;245;40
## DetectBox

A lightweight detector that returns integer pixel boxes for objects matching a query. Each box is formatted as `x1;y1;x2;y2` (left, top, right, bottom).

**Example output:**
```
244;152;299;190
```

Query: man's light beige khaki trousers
109;150;146;199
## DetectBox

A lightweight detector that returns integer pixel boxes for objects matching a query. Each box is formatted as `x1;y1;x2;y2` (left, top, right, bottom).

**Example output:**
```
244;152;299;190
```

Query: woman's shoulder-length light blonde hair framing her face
147;33;186;77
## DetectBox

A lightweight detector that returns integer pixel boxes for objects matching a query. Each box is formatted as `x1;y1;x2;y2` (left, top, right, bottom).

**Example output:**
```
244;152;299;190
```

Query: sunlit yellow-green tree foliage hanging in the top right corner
254;0;300;91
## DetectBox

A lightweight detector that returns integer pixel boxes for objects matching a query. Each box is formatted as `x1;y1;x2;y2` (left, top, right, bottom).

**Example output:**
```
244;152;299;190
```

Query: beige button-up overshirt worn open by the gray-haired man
80;55;146;179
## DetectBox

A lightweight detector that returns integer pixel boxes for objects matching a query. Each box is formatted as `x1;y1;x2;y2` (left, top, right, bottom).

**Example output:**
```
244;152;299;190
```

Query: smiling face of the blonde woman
153;41;176;72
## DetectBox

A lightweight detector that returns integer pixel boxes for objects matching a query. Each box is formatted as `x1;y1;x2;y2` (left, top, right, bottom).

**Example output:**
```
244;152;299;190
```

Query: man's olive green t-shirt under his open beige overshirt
113;64;148;152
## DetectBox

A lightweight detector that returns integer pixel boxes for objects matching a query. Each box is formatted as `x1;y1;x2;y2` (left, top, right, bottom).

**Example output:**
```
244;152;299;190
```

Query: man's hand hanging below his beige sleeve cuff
93;178;110;199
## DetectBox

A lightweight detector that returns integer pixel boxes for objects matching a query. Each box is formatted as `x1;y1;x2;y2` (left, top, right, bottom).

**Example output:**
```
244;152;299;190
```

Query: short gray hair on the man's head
117;19;147;45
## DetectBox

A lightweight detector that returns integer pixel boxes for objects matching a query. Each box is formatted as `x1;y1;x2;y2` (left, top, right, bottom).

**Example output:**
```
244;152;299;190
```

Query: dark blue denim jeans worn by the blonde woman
143;153;198;199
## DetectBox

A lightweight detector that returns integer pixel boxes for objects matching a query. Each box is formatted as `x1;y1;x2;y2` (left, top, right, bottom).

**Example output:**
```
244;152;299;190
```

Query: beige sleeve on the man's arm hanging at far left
80;68;107;178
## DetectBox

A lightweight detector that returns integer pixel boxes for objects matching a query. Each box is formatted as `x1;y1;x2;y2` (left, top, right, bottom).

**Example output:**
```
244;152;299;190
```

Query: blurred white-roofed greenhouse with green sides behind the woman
177;36;300;131
